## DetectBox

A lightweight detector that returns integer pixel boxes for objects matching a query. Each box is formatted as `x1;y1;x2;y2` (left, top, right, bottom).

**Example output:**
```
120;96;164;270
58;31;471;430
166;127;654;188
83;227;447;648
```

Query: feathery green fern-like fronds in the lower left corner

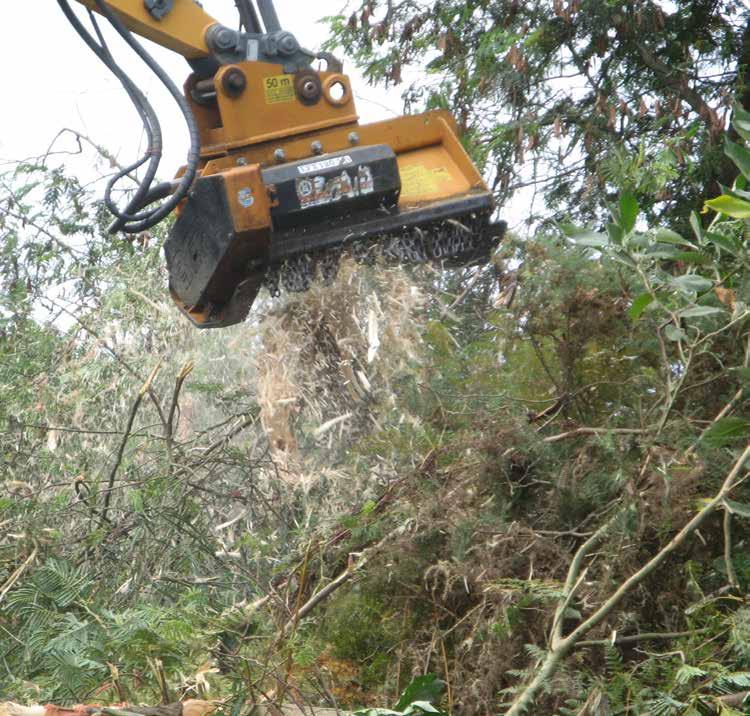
4;559;217;703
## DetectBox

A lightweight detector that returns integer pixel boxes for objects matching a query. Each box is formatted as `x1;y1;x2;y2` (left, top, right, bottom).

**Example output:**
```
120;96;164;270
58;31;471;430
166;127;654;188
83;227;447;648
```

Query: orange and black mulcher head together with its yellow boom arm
59;0;505;328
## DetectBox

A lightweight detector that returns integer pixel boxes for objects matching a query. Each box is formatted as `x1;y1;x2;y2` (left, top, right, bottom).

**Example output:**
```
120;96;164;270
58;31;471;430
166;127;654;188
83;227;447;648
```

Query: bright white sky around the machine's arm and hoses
0;0;402;172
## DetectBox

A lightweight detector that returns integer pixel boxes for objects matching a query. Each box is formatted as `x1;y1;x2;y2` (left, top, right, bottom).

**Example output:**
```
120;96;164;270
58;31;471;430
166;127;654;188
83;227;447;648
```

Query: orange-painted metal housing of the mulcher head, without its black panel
173;62;500;327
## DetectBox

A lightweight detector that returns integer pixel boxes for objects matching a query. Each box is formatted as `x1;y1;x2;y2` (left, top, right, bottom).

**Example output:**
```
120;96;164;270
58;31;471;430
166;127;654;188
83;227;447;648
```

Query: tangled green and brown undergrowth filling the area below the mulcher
0;144;750;714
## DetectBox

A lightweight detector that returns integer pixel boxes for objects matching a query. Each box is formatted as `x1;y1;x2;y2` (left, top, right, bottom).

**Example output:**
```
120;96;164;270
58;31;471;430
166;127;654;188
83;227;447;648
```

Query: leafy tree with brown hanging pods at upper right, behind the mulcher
329;0;750;225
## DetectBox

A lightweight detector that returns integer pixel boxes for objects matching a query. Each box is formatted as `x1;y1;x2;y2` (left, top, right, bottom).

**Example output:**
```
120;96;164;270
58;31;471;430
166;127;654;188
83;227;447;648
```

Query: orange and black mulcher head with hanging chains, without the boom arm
165;62;505;328
